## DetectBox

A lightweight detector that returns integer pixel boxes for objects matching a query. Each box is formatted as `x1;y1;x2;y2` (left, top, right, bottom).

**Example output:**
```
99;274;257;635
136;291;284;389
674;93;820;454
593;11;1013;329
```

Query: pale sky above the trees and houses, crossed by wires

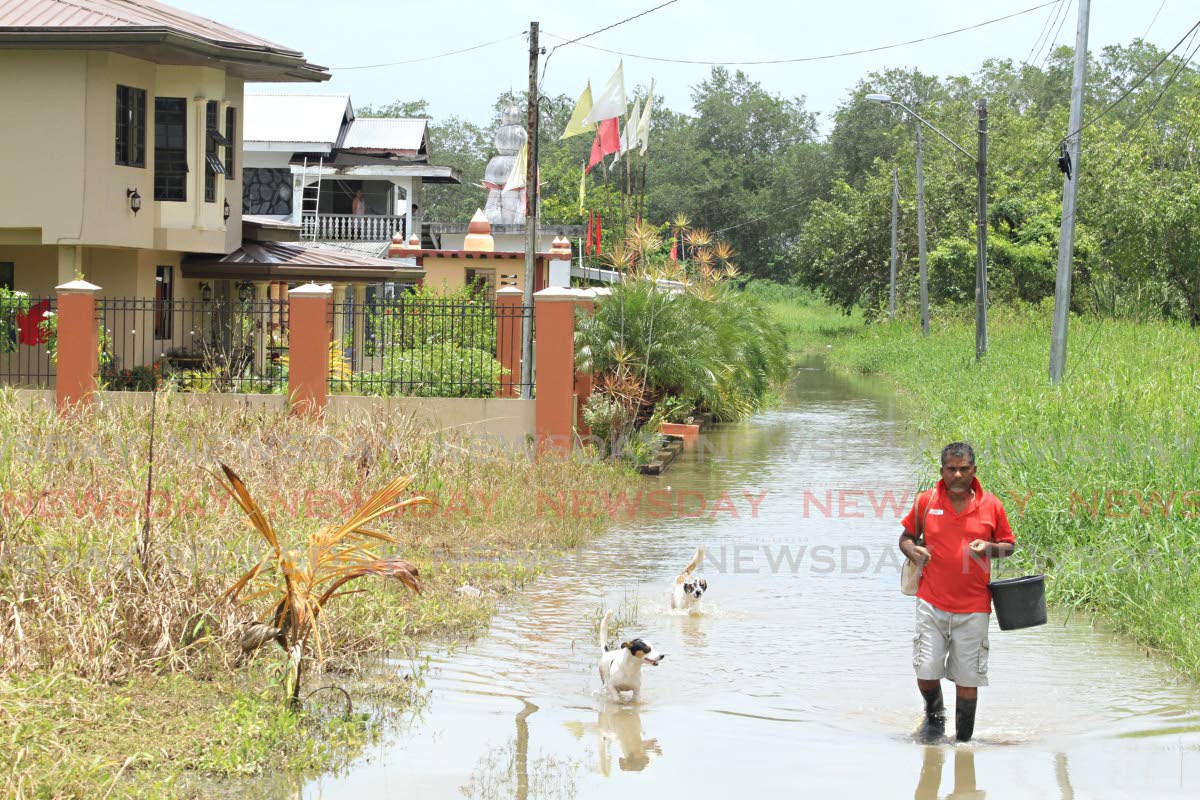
174;0;1200;131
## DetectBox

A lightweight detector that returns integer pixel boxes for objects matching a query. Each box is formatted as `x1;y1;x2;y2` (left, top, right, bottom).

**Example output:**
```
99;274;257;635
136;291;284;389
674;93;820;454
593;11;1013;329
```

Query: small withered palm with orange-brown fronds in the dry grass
218;464;430;705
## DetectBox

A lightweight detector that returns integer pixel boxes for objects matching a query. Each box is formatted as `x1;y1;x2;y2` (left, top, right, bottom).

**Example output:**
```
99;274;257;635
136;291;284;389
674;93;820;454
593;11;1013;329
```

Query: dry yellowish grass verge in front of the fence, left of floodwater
0;392;632;798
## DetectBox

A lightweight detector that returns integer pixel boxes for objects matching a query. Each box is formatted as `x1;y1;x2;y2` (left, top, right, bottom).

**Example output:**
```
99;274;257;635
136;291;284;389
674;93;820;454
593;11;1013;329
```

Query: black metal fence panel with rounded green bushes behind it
330;294;533;397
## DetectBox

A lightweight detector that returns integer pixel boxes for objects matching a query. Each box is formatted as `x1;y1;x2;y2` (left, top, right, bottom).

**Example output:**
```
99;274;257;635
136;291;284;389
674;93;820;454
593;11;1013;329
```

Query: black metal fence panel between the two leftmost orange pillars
96;297;288;393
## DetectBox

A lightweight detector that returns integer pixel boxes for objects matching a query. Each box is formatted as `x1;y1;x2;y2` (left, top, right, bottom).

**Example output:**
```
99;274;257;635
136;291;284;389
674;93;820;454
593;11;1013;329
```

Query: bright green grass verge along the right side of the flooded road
830;308;1200;675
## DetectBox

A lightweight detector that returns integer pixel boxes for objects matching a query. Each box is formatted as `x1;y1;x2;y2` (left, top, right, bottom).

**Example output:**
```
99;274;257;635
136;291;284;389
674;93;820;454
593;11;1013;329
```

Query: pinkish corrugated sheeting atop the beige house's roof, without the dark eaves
0;0;294;56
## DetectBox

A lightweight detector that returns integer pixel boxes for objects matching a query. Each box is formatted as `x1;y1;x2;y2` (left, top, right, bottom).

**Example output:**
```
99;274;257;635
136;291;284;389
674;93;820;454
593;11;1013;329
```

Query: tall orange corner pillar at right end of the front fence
533;288;580;453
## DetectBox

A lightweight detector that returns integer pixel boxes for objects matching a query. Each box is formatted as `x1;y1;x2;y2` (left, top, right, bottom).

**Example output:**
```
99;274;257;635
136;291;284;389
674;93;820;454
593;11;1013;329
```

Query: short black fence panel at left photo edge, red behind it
0;293;58;389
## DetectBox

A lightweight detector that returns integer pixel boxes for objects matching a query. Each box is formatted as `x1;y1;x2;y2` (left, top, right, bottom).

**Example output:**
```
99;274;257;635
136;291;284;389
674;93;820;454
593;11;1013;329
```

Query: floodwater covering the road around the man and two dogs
300;368;1200;800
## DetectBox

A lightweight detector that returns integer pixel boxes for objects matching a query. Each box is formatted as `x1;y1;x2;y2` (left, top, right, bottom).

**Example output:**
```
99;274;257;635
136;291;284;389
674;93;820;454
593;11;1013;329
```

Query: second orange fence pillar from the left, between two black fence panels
288;283;334;416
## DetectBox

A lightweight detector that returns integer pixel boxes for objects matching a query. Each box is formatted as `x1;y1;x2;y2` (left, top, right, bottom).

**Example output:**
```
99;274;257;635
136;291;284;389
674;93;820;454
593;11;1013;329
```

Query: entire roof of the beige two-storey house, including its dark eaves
0;0;329;80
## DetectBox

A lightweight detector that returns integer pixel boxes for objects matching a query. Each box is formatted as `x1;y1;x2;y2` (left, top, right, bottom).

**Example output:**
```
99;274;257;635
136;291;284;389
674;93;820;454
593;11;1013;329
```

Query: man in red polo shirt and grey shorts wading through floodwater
900;441;1016;741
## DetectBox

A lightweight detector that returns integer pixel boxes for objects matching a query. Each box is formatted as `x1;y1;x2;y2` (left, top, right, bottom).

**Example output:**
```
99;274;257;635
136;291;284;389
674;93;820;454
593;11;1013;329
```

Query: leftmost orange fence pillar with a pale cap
54;281;100;414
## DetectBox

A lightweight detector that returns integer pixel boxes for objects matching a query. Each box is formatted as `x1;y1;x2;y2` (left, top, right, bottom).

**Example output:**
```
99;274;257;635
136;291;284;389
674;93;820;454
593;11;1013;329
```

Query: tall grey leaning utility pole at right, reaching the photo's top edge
1050;0;1091;384
